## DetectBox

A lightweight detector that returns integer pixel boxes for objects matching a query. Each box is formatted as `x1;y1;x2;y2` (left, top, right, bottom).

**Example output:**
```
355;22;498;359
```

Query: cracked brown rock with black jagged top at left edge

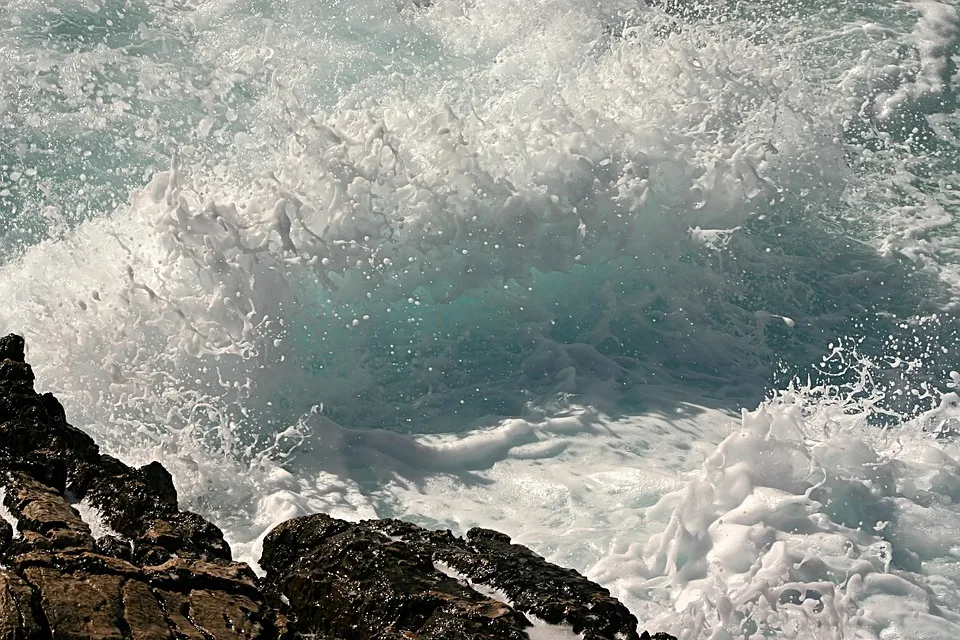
0;336;289;640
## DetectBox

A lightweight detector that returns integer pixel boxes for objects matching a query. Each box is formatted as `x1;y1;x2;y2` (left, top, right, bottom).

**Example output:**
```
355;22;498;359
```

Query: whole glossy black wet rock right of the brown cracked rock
260;514;669;640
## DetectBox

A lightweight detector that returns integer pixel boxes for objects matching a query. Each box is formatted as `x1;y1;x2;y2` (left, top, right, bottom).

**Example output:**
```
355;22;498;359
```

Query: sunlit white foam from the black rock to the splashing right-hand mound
370;378;960;639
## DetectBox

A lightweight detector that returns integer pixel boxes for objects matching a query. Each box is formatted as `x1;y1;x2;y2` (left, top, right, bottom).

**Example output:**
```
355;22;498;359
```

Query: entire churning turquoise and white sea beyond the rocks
0;0;960;640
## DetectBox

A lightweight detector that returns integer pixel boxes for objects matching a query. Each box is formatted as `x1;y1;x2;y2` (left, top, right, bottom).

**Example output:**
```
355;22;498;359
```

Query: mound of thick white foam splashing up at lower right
593;369;960;640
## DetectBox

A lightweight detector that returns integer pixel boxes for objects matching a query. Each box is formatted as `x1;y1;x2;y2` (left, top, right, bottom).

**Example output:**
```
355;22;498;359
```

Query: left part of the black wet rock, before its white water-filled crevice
260;514;530;640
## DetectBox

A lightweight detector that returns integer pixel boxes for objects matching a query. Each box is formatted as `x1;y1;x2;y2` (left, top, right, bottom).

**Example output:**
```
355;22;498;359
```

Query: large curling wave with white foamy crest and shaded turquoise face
5;0;956;447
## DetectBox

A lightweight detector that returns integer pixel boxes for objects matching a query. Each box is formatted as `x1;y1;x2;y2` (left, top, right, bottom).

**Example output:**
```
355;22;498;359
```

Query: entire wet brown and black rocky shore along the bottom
0;335;671;640
